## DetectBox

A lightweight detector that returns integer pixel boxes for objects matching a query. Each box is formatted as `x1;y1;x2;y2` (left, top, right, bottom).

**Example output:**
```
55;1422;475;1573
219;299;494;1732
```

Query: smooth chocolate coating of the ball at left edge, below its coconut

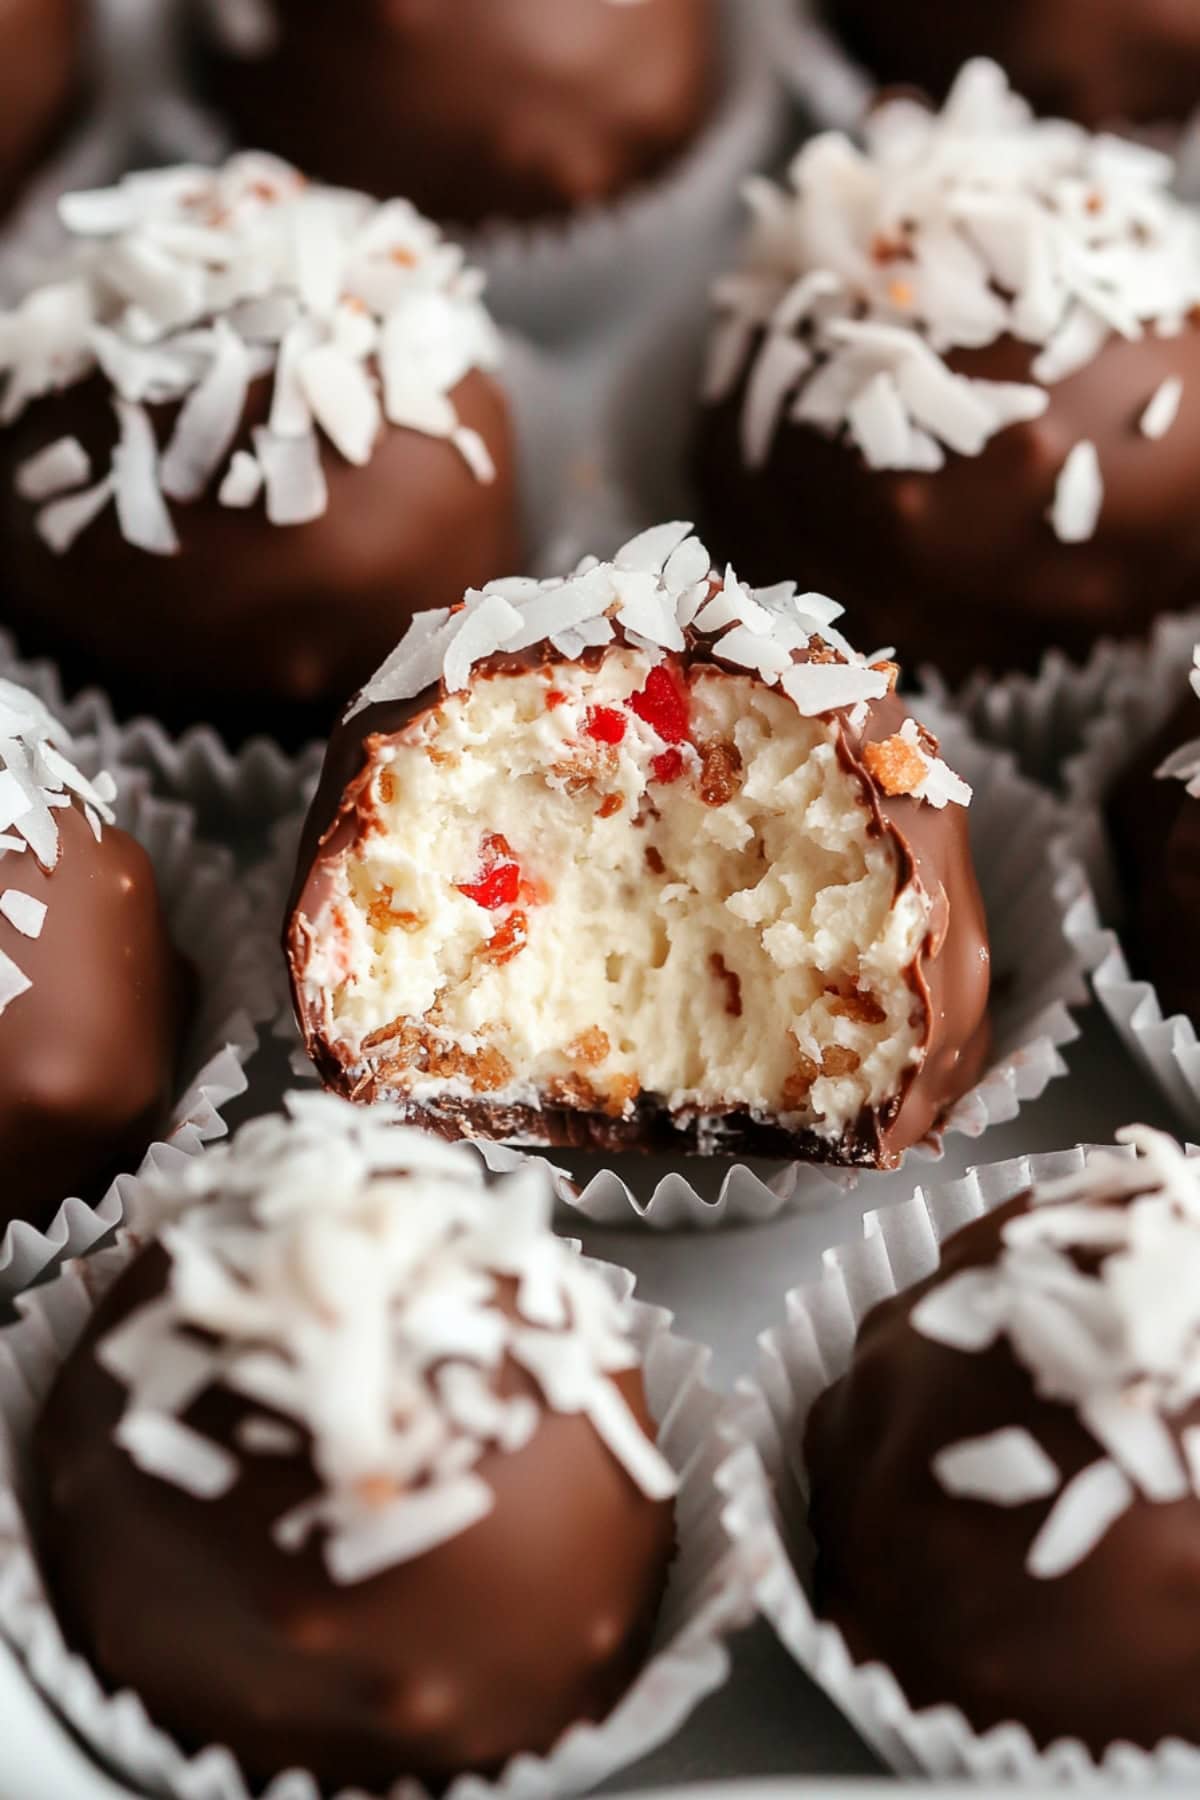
0;806;187;1226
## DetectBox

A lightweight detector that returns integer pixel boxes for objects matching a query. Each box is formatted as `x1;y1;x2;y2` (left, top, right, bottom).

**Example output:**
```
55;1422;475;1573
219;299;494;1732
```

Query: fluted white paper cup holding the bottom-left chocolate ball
0;1237;754;1800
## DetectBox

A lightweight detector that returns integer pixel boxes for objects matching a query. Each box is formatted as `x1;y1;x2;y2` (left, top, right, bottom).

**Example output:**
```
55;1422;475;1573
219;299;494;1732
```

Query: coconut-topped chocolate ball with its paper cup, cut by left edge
0;680;270;1294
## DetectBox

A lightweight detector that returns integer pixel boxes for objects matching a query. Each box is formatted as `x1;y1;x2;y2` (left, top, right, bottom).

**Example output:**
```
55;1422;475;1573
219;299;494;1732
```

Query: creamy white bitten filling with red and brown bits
306;650;928;1139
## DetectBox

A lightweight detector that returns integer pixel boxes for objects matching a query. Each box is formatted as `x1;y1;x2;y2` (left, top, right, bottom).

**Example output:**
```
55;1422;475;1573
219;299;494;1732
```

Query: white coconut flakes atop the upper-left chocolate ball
0;153;500;554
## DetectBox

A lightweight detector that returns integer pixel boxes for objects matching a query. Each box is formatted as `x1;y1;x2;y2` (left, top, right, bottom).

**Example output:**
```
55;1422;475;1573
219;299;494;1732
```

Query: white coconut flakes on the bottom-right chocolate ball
912;1125;1200;1580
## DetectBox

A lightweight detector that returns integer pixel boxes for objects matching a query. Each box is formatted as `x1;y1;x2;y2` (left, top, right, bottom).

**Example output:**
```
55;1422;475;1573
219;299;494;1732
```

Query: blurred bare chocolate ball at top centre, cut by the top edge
196;0;716;225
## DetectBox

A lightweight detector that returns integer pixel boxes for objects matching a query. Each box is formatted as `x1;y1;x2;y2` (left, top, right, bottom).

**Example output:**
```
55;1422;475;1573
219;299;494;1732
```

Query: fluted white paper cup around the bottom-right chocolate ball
723;1148;1200;1787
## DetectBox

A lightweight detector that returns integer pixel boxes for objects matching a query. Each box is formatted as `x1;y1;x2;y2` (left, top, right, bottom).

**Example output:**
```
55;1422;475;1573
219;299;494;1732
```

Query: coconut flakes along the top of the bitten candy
345;522;972;808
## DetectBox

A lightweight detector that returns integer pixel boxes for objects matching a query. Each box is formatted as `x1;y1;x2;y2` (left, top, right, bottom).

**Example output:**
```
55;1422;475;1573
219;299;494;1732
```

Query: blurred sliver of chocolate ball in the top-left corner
0;0;85;214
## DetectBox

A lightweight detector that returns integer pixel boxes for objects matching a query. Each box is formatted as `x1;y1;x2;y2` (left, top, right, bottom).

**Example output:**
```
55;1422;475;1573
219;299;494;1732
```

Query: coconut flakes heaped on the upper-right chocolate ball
705;59;1200;544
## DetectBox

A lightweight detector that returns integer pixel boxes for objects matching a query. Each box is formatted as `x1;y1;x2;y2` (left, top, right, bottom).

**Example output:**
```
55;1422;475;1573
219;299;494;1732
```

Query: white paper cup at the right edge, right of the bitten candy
1065;614;1200;1136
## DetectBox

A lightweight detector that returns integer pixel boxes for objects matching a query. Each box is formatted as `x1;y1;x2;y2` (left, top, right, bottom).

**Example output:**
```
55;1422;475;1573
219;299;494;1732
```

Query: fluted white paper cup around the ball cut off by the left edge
0;759;272;1300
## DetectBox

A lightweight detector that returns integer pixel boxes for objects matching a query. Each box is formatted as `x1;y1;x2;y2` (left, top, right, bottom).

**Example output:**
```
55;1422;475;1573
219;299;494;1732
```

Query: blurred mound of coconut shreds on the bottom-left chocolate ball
97;1094;676;1582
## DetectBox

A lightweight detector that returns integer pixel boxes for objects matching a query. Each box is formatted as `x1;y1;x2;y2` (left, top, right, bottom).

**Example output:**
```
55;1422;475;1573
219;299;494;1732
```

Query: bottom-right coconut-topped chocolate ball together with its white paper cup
725;1127;1200;1782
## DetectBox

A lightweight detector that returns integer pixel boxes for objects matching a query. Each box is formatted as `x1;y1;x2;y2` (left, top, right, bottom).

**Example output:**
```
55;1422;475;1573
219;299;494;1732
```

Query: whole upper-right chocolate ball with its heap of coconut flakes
694;61;1200;679
